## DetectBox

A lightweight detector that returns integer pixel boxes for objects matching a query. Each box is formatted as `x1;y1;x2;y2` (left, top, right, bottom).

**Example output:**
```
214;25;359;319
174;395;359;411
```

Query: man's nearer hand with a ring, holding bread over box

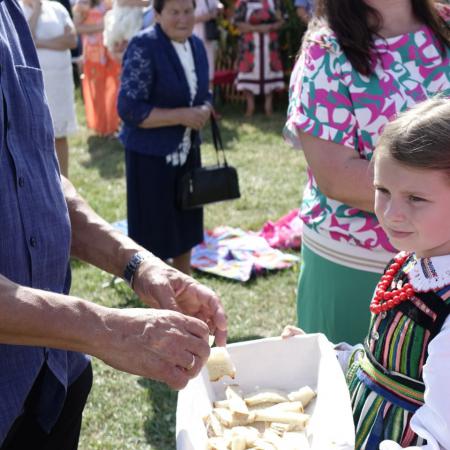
97;308;210;389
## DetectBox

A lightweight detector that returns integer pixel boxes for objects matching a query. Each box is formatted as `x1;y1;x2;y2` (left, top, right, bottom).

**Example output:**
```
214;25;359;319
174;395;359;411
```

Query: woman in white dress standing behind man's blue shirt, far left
22;0;77;177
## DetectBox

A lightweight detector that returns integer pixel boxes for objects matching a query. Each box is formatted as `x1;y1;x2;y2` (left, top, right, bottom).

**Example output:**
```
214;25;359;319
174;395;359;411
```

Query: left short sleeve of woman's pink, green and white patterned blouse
283;31;357;149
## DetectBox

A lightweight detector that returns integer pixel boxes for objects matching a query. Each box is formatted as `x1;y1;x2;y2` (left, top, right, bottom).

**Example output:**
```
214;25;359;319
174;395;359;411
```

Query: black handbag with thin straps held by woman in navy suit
177;115;241;210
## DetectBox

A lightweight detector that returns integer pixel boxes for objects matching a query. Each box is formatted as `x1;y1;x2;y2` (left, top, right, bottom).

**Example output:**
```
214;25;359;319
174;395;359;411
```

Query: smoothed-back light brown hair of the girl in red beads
375;97;450;178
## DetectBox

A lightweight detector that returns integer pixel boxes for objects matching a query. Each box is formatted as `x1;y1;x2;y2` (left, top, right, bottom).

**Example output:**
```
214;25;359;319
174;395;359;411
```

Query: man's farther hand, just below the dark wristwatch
133;257;227;346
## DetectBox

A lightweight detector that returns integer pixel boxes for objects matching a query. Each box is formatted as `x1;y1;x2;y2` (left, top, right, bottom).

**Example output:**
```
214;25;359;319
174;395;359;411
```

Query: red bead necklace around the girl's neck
370;252;414;314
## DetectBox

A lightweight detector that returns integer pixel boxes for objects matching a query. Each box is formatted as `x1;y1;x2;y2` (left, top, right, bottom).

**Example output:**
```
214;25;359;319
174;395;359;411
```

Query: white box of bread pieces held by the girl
176;334;355;450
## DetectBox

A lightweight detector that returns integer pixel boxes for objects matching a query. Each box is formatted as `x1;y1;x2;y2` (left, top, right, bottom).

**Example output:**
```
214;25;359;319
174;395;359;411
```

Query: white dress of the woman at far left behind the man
21;0;77;138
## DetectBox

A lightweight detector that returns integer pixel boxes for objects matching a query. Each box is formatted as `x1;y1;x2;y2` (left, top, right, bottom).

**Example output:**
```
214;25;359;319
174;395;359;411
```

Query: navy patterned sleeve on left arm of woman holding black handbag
117;35;154;126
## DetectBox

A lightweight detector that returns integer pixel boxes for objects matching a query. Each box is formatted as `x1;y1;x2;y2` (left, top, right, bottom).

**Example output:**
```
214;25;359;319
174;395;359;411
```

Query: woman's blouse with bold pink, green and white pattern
284;6;450;252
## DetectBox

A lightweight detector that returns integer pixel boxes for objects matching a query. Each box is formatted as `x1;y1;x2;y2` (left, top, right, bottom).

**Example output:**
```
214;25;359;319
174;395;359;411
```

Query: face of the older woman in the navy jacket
155;0;195;42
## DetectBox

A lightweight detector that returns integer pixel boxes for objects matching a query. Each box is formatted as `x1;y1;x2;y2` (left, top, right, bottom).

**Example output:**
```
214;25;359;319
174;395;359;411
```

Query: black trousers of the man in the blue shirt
0;364;92;450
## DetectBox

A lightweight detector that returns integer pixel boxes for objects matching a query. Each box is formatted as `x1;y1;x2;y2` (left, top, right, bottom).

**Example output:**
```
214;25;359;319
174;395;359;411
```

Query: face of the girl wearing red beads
374;151;450;257
